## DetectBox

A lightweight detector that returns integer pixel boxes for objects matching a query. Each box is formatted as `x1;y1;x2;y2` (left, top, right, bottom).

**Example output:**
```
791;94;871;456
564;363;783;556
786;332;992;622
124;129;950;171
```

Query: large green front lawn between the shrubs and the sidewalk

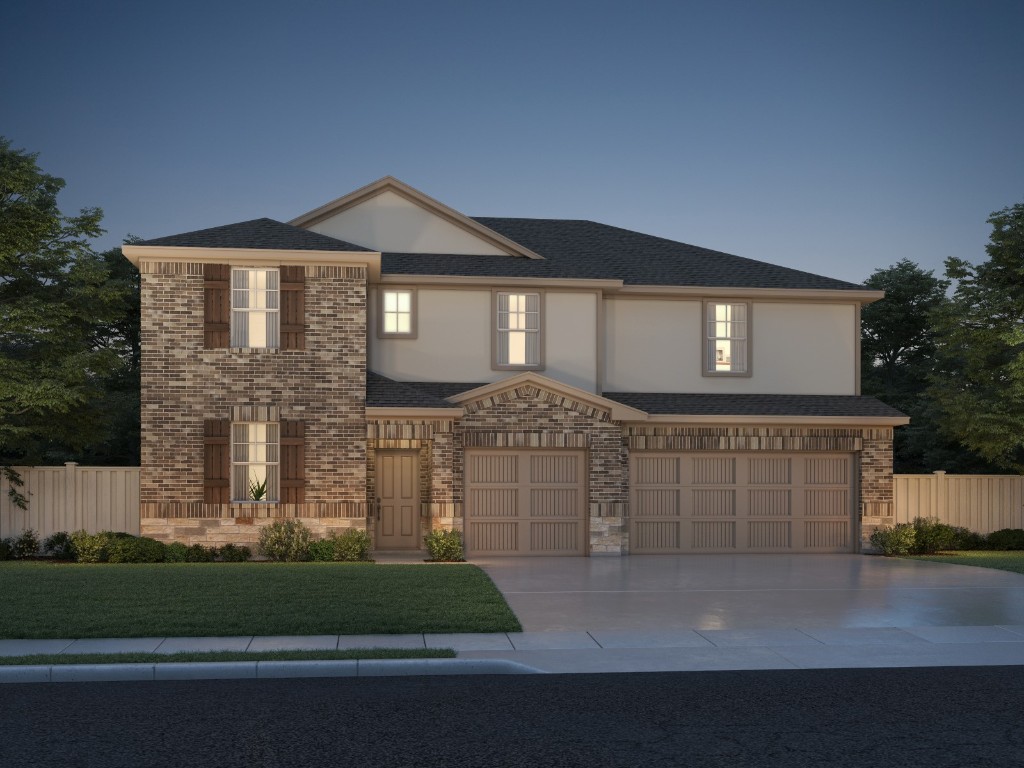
0;562;521;639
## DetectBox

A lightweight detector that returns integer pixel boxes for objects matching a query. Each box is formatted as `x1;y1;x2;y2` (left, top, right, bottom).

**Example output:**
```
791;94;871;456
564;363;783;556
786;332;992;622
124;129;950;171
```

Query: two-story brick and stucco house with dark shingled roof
124;177;907;556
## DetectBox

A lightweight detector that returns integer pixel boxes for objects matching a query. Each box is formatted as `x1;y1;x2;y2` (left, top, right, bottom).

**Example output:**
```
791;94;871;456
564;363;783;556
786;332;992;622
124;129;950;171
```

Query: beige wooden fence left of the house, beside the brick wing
0;462;139;539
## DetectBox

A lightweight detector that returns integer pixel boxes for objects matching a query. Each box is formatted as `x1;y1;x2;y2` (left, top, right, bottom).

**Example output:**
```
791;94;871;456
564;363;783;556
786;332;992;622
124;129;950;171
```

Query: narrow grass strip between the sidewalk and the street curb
0;648;455;667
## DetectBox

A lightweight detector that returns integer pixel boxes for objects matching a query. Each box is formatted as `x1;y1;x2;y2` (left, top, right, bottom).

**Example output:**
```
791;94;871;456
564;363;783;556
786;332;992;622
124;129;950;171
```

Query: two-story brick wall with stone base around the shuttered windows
140;261;367;544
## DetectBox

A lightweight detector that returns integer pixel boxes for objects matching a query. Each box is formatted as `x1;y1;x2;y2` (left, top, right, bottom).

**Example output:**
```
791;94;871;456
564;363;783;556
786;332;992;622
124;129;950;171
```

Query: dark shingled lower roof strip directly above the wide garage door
604;392;904;419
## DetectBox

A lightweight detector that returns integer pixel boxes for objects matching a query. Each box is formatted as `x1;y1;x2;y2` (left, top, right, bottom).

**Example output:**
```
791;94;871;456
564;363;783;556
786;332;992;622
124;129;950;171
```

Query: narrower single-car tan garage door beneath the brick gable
465;451;587;555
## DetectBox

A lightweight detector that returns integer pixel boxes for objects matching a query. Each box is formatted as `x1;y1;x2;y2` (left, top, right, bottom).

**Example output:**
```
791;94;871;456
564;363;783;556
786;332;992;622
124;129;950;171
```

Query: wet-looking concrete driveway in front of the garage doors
473;555;1024;632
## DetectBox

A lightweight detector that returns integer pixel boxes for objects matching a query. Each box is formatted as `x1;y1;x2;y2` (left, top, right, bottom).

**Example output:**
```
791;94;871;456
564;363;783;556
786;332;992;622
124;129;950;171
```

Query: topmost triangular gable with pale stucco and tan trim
289;176;542;259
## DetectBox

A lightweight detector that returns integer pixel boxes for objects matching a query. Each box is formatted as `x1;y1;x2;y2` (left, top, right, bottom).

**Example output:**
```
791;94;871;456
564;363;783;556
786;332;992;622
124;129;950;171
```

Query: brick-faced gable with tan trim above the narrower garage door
447;372;647;421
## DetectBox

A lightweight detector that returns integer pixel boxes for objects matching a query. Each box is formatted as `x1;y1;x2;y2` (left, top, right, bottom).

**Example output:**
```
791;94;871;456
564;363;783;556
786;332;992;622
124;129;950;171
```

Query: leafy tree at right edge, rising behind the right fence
929;204;1024;472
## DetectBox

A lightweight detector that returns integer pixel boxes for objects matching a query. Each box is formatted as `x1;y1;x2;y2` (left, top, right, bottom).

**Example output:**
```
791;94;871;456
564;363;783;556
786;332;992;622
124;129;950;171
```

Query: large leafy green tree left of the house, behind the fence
0;137;127;466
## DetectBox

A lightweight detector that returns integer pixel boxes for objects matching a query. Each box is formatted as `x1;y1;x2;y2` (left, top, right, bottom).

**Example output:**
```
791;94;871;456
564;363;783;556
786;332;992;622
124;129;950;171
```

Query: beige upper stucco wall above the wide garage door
603;299;858;394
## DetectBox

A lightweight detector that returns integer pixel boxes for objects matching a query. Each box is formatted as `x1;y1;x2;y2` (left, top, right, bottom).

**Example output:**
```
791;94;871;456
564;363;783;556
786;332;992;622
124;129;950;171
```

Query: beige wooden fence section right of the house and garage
893;472;1024;534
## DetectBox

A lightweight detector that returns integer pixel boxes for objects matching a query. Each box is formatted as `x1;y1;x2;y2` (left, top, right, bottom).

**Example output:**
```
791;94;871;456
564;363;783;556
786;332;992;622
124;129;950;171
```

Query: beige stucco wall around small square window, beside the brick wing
369;287;597;391
